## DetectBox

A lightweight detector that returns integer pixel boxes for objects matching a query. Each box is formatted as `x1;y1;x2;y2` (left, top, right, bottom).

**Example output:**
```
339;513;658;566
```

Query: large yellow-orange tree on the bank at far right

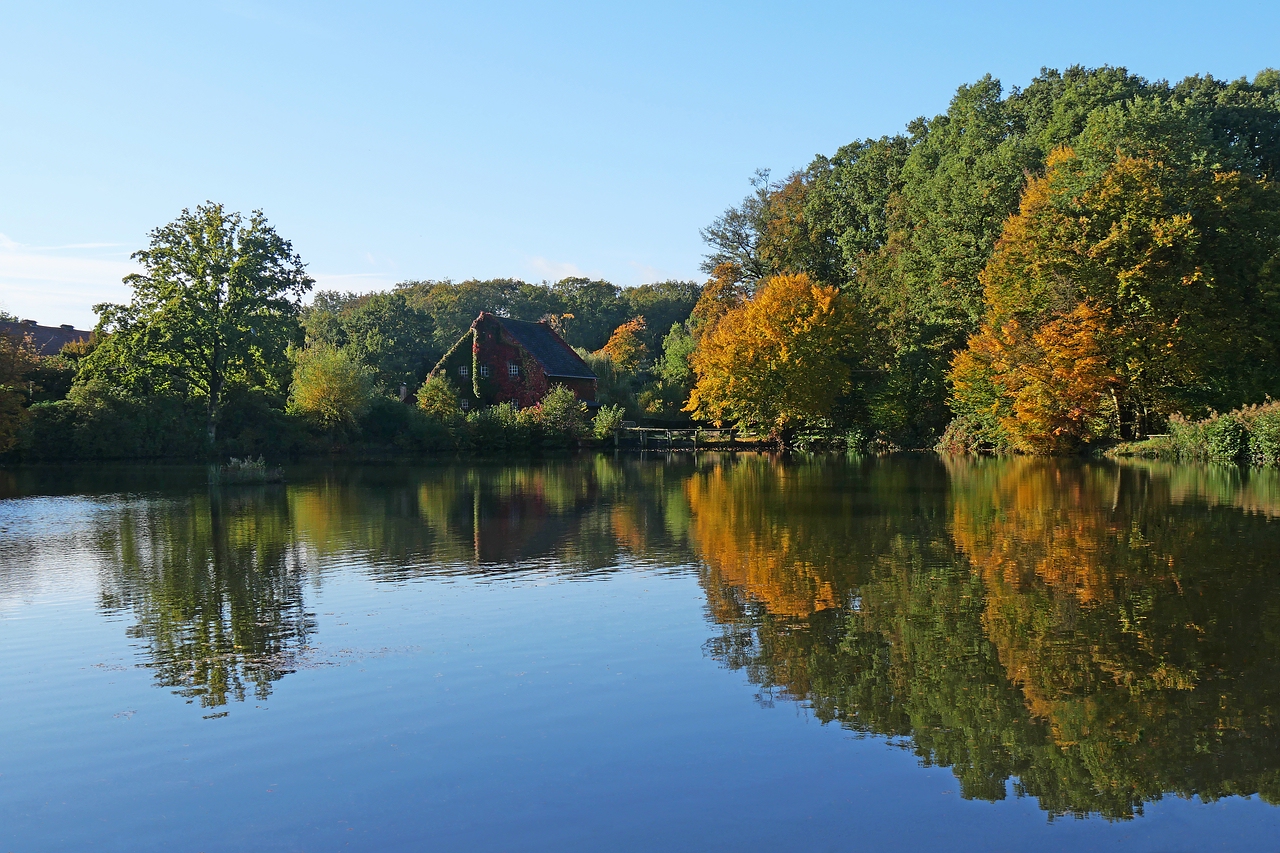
950;140;1280;452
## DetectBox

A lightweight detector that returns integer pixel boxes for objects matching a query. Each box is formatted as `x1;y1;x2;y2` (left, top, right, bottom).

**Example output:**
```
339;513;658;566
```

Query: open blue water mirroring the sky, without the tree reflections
0;461;1280;850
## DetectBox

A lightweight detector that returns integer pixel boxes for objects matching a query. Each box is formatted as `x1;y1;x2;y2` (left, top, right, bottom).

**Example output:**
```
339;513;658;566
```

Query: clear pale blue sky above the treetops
0;0;1280;328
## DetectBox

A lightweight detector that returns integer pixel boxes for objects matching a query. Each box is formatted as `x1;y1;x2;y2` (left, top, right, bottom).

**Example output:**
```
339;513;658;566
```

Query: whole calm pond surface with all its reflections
0;455;1280;853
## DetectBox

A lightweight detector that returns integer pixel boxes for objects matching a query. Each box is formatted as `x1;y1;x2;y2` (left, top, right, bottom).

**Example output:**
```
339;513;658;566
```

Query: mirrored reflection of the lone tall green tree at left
99;488;312;707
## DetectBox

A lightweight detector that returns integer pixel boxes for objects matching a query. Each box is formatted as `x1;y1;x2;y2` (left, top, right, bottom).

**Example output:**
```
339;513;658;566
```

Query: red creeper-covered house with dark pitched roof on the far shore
431;311;595;409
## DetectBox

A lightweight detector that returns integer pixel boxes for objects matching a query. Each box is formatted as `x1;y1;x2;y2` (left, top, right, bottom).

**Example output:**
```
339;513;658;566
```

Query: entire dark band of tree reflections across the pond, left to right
10;455;1280;818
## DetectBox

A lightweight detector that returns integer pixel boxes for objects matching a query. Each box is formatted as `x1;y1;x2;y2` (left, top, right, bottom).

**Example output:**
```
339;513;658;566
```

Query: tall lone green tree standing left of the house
78;202;314;443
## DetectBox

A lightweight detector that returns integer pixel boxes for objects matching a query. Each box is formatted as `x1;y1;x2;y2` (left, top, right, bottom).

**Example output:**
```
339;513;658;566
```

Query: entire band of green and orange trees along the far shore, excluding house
0;67;1280;462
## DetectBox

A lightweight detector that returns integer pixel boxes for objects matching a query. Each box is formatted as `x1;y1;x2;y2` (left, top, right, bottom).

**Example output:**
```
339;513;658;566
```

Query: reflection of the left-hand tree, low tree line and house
70;459;690;708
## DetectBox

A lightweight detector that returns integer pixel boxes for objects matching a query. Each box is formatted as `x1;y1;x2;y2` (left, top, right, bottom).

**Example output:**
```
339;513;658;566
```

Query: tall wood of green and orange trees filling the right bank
689;67;1280;453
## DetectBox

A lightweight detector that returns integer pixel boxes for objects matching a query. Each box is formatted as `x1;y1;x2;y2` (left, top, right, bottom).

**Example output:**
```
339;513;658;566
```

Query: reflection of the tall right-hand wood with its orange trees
689;460;1280;817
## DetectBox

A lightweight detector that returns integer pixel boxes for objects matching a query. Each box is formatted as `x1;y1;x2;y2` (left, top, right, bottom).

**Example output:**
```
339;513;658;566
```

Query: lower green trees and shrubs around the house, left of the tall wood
0;202;701;460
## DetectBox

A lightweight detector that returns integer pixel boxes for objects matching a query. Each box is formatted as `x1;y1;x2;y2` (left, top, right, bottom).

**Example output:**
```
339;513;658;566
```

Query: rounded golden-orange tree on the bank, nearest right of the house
685;273;855;442
